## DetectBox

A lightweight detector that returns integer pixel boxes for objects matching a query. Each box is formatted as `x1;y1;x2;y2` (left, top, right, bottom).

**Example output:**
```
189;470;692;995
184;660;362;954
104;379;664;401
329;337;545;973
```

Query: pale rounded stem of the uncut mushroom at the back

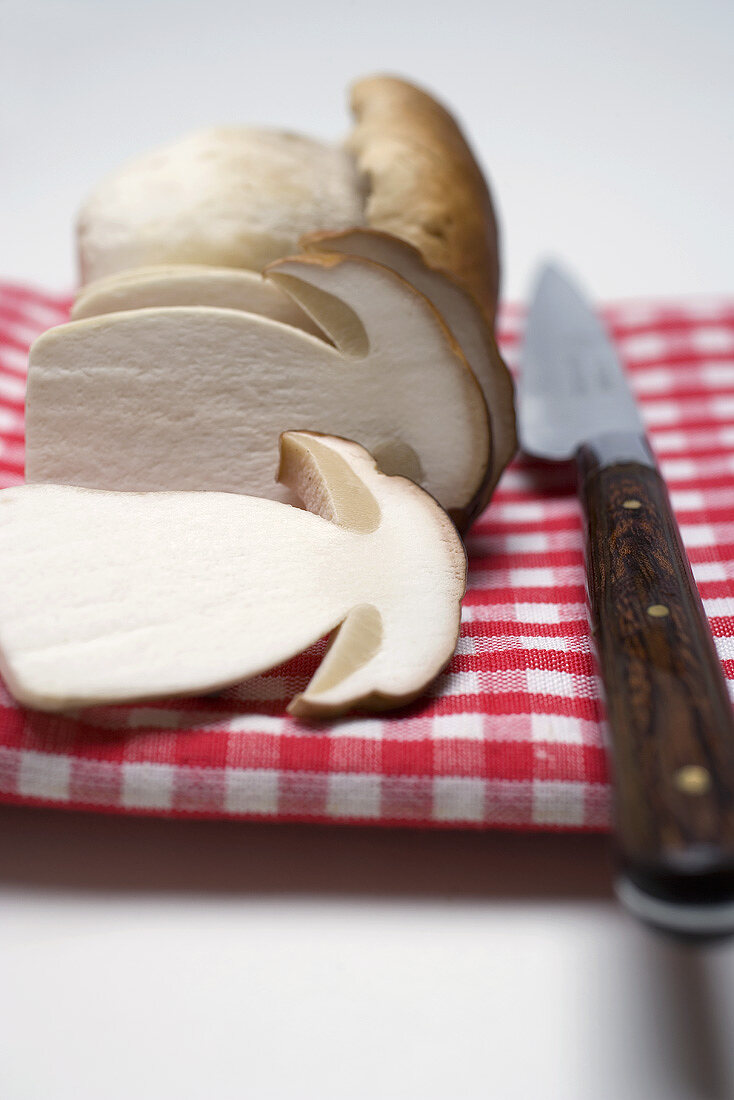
77;127;363;283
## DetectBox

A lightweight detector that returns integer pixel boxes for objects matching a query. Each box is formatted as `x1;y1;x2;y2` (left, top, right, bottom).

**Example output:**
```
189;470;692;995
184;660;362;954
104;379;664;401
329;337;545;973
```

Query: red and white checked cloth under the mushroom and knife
0;284;734;829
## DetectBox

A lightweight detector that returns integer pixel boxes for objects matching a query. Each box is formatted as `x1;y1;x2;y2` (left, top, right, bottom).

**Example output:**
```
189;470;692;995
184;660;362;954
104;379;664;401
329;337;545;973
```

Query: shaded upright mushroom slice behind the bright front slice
26;254;490;516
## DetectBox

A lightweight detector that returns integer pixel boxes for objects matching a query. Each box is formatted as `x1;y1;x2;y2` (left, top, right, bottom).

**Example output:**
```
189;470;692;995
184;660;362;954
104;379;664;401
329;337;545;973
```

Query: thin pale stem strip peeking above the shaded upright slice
72;264;319;334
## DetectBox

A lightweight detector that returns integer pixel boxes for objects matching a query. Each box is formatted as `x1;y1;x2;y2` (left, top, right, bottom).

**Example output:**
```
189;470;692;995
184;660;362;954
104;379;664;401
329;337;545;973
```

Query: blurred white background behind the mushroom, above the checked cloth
0;0;734;298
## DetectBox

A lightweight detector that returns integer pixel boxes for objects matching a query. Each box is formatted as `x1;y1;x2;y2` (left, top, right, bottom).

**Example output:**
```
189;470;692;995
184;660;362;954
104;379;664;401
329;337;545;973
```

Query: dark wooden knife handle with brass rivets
578;448;734;936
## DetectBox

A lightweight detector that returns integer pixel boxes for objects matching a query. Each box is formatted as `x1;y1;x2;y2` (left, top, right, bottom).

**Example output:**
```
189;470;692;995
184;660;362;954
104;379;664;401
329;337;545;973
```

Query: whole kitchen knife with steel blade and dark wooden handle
518;266;734;938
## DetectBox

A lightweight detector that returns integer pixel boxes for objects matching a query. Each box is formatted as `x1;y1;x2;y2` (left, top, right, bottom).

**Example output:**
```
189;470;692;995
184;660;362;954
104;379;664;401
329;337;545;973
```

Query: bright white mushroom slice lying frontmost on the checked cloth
0;432;465;716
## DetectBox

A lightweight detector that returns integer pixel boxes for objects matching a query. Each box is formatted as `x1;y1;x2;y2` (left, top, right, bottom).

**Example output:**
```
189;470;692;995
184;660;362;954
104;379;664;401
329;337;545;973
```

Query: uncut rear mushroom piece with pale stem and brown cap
77;76;500;326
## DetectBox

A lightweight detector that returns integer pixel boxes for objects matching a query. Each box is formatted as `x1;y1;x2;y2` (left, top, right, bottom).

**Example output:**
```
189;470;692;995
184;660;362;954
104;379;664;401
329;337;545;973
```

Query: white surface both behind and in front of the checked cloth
0;0;734;1100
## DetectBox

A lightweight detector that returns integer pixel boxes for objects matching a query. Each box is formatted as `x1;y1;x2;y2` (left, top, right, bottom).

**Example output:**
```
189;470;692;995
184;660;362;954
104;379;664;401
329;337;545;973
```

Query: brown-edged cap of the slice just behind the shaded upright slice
300;229;517;512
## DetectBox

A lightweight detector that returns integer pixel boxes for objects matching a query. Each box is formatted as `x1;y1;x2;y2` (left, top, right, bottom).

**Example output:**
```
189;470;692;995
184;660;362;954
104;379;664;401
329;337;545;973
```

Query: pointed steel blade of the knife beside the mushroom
518;265;645;461
